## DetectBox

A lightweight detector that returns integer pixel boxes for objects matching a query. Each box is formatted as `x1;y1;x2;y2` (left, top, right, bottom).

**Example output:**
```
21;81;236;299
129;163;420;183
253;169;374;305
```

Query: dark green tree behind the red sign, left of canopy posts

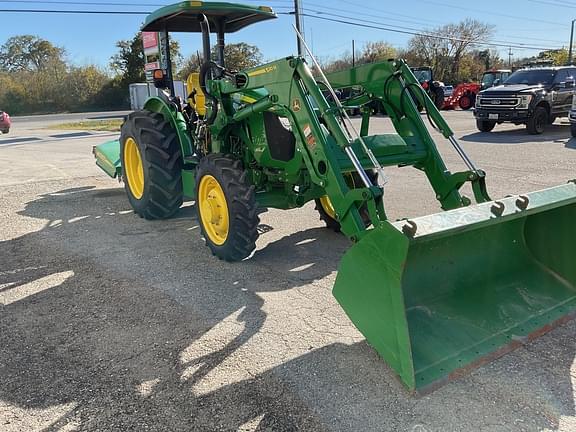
110;32;181;88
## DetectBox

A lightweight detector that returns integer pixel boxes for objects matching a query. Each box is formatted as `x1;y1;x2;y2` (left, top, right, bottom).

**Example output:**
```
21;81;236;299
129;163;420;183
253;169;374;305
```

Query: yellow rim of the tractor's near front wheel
197;175;230;246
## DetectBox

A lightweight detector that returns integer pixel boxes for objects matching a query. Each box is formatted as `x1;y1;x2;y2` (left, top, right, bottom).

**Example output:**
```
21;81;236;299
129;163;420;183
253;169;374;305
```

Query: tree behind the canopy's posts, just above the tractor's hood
178;42;262;80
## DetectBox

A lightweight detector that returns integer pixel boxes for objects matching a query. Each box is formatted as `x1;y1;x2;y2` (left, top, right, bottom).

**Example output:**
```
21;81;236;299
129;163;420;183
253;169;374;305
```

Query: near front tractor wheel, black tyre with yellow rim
196;153;260;261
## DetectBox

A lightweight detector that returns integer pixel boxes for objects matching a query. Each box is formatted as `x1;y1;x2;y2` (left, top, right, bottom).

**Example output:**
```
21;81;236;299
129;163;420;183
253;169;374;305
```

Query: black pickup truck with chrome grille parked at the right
474;66;576;134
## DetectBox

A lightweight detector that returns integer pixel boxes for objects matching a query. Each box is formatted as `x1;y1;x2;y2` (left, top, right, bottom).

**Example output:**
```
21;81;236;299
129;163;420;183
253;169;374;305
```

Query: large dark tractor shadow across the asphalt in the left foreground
0;187;342;431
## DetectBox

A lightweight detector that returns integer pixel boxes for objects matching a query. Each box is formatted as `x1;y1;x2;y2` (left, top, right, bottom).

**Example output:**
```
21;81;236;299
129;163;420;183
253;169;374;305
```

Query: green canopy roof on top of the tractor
142;1;276;33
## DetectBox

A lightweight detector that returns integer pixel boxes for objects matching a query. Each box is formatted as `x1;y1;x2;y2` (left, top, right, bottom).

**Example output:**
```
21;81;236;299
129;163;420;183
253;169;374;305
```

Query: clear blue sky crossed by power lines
0;0;576;68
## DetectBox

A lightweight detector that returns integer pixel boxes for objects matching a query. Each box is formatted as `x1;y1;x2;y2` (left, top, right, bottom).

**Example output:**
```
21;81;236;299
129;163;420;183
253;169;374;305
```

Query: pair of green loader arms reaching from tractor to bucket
210;57;489;241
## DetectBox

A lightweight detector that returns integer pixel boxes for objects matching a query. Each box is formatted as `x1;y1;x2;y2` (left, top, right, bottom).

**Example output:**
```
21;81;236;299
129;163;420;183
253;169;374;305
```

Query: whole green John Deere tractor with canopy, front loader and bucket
94;1;576;392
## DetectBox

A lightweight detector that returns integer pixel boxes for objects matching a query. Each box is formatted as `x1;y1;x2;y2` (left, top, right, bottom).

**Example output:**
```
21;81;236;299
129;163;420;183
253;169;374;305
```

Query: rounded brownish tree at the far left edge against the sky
0;35;64;72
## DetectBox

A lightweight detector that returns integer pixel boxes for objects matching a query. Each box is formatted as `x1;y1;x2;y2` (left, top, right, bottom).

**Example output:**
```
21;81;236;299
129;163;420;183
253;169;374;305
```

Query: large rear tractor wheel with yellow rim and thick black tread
120;111;183;219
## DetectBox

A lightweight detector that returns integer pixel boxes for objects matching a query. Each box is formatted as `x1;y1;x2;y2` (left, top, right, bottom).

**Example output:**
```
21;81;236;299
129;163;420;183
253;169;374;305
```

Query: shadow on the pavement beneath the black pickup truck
460;124;570;144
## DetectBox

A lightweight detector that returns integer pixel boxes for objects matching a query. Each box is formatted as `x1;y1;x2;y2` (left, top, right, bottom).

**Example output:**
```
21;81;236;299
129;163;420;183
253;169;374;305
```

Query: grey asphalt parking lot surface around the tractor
0;111;576;432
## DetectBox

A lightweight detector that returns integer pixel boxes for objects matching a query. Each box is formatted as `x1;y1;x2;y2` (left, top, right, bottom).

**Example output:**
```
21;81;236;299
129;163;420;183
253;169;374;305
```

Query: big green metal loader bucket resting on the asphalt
333;183;576;393
